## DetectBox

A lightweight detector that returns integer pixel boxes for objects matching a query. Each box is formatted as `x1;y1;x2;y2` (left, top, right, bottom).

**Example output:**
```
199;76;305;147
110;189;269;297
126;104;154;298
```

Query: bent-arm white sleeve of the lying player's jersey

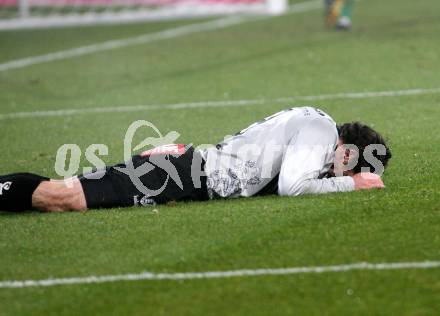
278;119;354;196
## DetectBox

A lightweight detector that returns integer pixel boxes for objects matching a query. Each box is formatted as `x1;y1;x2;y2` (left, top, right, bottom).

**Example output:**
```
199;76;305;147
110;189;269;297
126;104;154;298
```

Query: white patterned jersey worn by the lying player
200;107;354;198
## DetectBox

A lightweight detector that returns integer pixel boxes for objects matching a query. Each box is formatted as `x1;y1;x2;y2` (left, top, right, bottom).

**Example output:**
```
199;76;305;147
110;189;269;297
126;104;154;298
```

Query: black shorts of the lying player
78;145;208;209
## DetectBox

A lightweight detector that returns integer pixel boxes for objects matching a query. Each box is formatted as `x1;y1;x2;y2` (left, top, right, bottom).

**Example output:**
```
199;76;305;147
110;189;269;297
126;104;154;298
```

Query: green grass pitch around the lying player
0;0;440;315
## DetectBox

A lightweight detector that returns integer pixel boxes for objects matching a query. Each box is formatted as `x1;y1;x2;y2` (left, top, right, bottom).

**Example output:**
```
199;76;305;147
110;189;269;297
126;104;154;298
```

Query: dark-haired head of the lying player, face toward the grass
334;122;391;175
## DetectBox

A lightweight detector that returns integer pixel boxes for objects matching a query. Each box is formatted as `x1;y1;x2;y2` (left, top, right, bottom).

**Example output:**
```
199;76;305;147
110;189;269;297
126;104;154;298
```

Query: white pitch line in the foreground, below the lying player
0;261;440;289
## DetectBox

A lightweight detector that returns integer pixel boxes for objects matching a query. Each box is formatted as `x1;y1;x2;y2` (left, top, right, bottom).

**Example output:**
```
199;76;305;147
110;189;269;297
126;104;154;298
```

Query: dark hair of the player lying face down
338;122;391;173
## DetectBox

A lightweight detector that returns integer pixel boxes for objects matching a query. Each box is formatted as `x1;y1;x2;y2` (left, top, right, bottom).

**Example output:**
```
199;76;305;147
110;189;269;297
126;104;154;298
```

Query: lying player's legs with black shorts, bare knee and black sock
0;148;208;212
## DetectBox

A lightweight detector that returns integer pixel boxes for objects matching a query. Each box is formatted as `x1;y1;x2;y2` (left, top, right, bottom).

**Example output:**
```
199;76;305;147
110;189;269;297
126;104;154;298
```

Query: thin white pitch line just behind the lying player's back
0;88;440;120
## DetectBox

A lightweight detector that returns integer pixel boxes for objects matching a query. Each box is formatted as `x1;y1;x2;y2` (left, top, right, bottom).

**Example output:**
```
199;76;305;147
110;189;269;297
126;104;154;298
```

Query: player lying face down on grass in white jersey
0;107;391;212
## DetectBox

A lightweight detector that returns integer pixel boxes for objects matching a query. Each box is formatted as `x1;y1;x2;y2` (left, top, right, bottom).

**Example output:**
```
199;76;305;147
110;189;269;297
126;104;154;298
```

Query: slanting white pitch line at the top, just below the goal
0;0;322;72
